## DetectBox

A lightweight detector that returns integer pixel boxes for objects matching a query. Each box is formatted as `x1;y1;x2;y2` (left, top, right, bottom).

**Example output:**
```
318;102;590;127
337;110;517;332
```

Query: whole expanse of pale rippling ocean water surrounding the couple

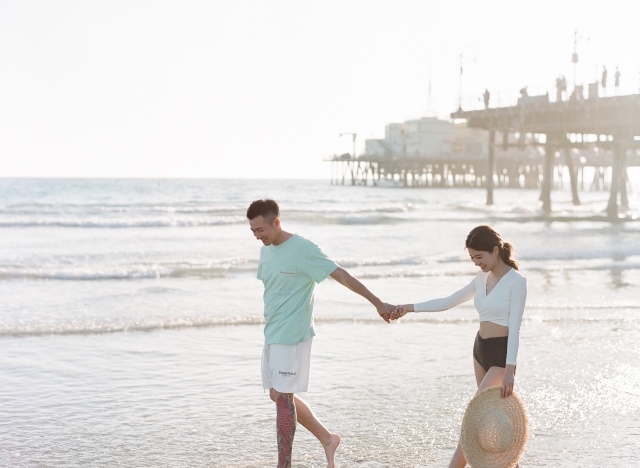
0;179;640;467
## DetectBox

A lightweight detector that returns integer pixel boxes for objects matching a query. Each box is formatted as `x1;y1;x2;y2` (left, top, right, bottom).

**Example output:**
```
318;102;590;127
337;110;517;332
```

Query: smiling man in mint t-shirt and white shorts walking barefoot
247;199;395;468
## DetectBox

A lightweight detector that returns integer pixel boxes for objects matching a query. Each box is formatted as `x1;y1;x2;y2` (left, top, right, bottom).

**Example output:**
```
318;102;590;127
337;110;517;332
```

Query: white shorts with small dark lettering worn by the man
262;338;313;393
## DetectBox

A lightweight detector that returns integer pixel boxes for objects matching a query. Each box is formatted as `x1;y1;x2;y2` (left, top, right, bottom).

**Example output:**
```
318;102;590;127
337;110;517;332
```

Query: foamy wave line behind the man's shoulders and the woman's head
0;250;640;281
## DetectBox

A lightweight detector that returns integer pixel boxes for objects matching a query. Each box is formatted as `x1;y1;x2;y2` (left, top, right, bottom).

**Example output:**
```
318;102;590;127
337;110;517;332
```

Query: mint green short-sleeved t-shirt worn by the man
257;234;338;344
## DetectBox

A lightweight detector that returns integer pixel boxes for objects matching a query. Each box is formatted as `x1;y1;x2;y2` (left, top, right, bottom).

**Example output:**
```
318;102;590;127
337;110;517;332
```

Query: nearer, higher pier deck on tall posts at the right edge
451;94;640;218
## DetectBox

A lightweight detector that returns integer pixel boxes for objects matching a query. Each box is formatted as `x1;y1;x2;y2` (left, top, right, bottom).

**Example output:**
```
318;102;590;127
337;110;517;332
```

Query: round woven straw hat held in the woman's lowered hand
461;386;529;468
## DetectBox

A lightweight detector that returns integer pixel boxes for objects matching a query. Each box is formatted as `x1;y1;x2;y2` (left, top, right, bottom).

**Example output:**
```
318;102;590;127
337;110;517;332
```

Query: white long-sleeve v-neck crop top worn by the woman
413;268;527;365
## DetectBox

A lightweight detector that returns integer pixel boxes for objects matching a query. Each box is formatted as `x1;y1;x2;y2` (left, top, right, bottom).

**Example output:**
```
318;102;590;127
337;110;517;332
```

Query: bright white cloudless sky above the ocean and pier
0;0;640;178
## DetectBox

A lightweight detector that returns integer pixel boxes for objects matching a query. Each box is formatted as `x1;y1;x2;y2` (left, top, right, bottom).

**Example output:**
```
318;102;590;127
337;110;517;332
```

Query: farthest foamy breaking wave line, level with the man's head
0;196;640;228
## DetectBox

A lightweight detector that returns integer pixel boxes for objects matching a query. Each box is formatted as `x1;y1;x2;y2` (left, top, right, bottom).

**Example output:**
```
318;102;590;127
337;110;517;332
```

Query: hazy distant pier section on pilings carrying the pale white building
329;117;543;192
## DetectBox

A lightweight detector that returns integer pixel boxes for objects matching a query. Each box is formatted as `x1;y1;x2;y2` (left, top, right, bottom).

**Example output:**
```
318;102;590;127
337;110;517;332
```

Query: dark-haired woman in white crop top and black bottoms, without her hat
391;226;527;468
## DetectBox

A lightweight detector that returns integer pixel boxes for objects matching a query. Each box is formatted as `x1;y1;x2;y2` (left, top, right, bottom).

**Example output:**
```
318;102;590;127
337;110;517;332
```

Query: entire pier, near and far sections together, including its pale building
327;94;640;218
